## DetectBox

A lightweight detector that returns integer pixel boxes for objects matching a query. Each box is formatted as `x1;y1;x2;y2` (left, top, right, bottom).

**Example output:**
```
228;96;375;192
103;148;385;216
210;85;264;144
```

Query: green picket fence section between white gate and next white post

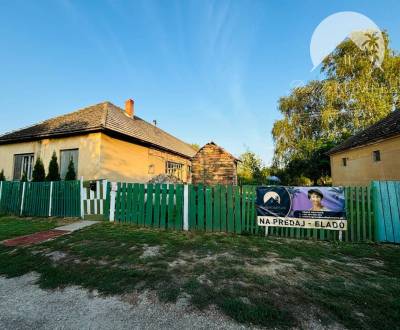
114;183;183;230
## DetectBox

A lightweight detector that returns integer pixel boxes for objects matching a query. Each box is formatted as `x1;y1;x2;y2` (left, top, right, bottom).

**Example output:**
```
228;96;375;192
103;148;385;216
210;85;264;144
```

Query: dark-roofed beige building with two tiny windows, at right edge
329;110;400;186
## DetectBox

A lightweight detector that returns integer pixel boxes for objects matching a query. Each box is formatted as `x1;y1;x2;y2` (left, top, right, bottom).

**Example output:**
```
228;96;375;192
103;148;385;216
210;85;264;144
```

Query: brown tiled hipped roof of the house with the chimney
0;102;196;157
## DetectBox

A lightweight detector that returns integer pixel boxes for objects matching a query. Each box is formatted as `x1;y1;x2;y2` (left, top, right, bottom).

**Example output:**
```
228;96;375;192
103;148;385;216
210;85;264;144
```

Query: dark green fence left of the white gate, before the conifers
0;181;81;217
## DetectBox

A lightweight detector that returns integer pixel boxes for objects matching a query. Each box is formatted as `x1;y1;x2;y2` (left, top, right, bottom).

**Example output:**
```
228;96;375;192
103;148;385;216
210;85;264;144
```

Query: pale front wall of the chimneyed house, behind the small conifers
0;133;101;180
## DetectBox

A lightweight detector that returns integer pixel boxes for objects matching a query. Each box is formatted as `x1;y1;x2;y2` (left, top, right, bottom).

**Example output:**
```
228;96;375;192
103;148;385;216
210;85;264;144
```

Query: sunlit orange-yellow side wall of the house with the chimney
100;134;191;183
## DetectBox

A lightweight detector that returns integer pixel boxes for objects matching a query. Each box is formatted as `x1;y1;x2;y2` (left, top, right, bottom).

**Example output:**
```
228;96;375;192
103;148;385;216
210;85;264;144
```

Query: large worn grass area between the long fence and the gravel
0;218;400;329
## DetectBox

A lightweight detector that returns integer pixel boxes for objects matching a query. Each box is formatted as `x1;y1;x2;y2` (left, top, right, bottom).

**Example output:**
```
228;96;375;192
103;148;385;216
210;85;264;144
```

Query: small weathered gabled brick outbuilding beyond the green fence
192;142;237;185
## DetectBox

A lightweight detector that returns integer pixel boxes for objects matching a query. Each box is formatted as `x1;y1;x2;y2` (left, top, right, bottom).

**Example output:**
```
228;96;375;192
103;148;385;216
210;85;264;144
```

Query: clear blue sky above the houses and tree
0;0;400;164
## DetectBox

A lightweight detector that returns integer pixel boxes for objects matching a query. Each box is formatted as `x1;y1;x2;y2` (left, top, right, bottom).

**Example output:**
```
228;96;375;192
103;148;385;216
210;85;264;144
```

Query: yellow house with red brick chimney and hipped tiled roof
0;100;196;182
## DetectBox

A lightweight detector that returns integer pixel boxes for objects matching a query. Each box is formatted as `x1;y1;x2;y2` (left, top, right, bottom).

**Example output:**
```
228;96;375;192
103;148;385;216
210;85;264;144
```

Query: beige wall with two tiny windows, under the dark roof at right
330;136;400;186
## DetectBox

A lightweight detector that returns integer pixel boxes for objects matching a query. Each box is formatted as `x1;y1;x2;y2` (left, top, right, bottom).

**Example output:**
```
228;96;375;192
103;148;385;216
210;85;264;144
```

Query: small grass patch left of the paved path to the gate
0;217;76;241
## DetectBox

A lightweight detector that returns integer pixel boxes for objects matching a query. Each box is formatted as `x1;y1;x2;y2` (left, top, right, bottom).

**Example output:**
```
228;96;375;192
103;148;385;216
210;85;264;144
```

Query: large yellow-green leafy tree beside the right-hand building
272;33;400;178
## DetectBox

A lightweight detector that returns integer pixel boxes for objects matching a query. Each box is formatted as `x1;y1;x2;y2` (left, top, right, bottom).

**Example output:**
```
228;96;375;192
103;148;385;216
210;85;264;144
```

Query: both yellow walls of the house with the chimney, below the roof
0;133;191;182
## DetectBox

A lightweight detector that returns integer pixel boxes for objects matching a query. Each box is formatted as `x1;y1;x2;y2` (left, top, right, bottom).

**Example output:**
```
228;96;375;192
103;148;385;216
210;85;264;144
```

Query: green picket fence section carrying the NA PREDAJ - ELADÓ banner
189;185;375;242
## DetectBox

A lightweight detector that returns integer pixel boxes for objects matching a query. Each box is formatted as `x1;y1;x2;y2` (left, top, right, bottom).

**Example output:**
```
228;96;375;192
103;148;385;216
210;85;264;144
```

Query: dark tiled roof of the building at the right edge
328;110;400;154
